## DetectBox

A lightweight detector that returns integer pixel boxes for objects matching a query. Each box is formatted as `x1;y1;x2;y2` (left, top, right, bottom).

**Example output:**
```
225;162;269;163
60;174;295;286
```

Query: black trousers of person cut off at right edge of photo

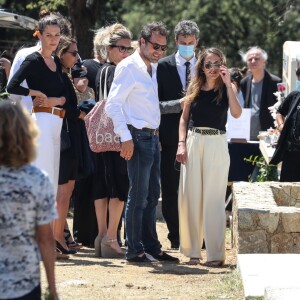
280;151;300;182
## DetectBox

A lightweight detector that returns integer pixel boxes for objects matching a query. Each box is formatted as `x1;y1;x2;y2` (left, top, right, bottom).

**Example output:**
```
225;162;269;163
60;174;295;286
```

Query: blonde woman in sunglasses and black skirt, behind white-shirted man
94;24;133;257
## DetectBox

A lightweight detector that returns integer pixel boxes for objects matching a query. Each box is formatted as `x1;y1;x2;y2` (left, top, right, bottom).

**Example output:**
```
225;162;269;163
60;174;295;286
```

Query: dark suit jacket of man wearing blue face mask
157;53;184;145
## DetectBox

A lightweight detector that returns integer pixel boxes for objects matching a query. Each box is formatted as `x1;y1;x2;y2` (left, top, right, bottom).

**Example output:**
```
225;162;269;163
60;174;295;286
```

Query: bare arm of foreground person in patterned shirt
36;224;58;300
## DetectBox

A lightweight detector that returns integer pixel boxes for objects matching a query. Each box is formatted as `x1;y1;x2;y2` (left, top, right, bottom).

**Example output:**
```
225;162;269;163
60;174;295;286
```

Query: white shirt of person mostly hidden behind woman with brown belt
7;42;41;113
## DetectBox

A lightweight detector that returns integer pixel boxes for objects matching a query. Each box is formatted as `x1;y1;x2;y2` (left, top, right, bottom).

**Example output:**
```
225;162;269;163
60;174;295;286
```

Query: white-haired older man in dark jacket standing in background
241;47;281;140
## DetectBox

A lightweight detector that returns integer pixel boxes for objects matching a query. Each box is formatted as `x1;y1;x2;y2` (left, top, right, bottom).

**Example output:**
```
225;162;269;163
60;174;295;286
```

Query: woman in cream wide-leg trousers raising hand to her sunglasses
176;48;242;266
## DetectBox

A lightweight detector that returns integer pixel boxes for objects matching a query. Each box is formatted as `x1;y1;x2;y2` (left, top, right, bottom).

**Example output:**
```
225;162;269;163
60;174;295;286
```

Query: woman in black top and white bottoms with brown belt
7;14;66;195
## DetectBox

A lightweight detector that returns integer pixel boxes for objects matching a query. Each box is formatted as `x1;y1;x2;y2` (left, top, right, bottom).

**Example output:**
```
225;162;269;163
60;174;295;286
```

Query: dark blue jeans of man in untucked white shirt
125;130;161;259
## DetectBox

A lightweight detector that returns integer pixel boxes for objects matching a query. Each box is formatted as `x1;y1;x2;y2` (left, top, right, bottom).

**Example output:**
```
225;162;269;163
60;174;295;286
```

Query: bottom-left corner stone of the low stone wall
238;230;269;253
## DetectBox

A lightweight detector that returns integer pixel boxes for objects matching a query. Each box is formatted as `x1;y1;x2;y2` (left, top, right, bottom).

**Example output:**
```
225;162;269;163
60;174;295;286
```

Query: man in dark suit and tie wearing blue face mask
157;20;200;249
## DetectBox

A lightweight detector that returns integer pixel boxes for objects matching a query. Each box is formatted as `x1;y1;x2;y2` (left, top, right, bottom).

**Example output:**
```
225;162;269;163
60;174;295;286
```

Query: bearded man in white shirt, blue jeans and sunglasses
106;22;178;263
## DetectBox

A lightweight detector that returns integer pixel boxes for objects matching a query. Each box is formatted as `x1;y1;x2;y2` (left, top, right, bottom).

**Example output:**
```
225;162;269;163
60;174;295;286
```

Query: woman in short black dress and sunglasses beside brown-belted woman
54;36;87;254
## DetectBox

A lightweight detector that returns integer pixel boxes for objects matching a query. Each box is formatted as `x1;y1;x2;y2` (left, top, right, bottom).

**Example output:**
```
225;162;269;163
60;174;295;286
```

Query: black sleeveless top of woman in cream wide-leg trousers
189;87;228;131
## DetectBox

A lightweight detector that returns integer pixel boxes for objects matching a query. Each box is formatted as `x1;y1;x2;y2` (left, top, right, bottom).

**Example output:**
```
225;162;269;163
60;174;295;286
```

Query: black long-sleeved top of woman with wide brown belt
7;52;65;99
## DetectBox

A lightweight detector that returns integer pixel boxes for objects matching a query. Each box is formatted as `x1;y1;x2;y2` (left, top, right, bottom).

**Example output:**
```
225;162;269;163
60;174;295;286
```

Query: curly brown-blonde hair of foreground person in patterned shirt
0;100;38;168
